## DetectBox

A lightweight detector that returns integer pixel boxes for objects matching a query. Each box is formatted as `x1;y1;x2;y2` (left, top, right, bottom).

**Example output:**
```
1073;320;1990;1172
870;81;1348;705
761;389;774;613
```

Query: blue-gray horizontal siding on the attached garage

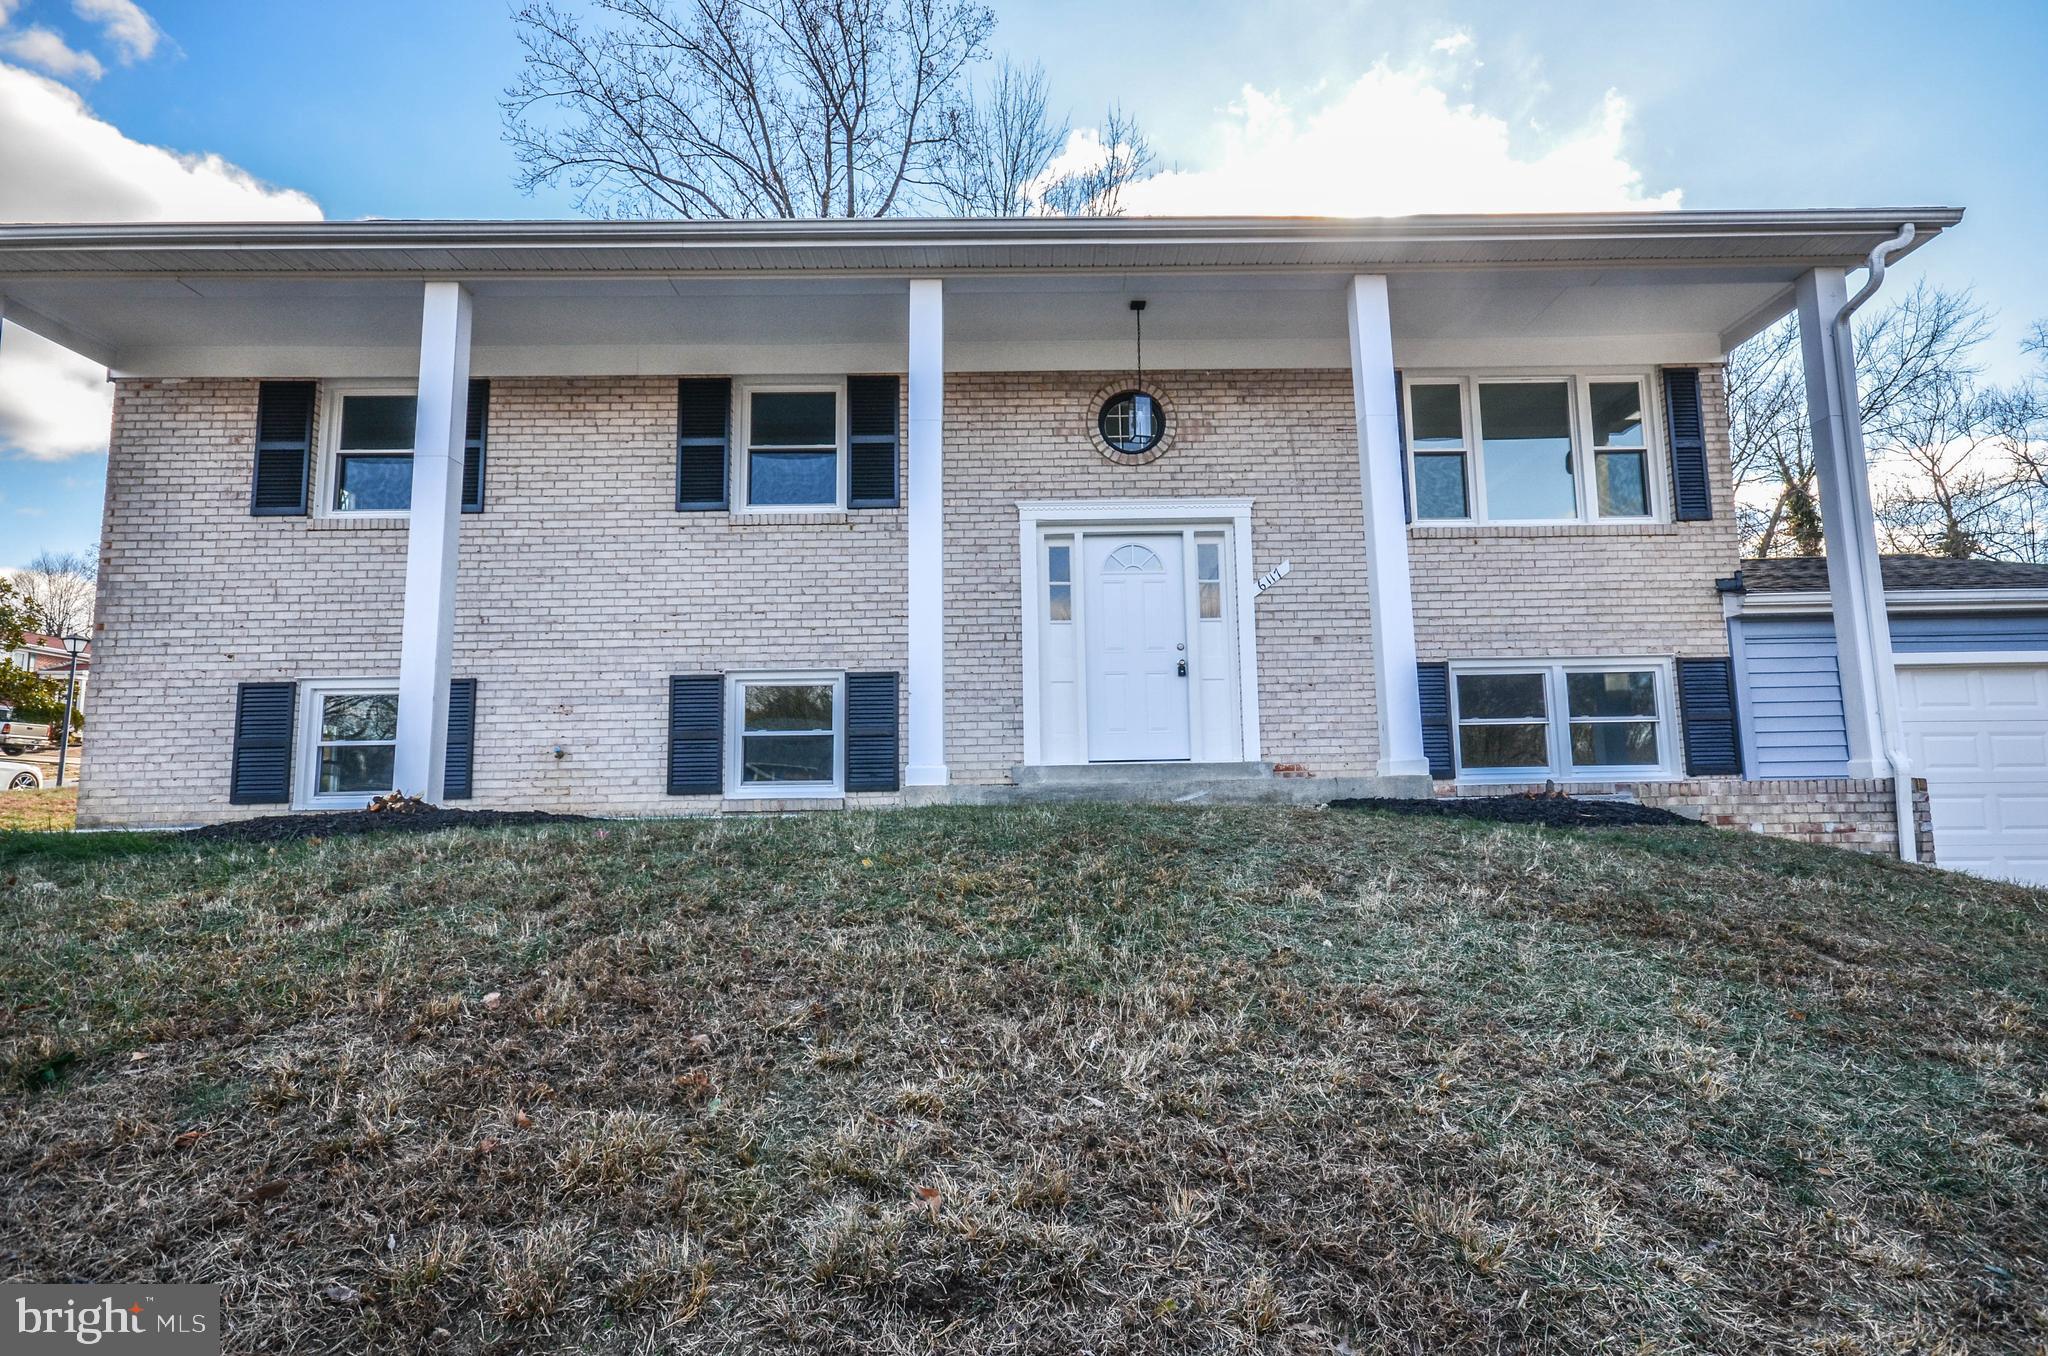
1729;612;2048;778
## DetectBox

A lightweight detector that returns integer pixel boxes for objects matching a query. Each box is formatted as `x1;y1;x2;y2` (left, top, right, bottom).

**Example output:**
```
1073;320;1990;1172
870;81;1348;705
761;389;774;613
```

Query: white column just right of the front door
1346;274;1430;776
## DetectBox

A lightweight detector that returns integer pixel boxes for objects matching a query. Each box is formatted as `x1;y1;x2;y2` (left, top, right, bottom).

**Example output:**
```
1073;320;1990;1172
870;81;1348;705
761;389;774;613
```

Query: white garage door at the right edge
1898;664;2048;885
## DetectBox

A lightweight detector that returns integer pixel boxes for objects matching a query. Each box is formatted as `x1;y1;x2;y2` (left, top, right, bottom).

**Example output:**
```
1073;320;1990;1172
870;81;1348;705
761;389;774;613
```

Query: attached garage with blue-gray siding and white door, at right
1724;555;2048;885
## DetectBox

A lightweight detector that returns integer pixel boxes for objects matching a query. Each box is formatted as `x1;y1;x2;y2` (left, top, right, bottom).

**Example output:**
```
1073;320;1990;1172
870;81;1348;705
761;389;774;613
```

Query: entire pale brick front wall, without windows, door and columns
82;369;1802;823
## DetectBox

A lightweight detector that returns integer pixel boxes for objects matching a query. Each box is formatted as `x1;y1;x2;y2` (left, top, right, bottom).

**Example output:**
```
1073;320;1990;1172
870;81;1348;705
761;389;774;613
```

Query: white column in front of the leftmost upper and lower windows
393;283;469;803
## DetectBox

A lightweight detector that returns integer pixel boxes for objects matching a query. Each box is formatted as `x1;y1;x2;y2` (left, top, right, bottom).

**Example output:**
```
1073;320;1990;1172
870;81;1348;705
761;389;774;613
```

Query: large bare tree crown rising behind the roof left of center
502;0;995;217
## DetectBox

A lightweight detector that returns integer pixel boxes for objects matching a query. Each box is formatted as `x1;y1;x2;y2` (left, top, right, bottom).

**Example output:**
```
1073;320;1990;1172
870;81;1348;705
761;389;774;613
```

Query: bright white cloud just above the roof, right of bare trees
1124;63;1679;217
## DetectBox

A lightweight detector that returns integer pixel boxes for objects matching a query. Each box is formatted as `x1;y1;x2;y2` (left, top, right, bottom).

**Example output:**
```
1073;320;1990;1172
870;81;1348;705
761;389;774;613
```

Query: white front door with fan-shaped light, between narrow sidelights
1081;533;1188;762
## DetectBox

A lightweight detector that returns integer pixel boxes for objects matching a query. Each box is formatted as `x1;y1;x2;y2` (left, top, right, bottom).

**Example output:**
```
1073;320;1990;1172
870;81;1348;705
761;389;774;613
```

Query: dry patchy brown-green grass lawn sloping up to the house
0;807;2048;1356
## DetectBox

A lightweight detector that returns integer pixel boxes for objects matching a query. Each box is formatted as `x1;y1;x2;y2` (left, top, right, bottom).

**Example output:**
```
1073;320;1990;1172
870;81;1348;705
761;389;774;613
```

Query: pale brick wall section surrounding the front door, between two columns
946;371;1378;785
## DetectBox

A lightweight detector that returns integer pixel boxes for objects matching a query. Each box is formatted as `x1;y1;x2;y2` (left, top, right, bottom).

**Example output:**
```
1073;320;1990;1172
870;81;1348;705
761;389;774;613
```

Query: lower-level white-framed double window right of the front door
1450;660;1673;780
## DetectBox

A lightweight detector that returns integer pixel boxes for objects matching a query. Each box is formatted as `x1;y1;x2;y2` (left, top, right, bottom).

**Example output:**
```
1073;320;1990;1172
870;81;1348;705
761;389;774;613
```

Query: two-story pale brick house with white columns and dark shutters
0;209;1990;872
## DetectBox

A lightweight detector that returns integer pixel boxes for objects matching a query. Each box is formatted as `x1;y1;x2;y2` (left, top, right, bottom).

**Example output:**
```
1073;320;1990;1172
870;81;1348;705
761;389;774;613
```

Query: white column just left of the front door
905;279;948;787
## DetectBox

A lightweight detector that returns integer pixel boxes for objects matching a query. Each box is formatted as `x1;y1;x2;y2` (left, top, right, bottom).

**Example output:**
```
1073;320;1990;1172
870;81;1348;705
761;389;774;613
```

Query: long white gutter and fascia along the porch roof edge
0;207;1962;279
